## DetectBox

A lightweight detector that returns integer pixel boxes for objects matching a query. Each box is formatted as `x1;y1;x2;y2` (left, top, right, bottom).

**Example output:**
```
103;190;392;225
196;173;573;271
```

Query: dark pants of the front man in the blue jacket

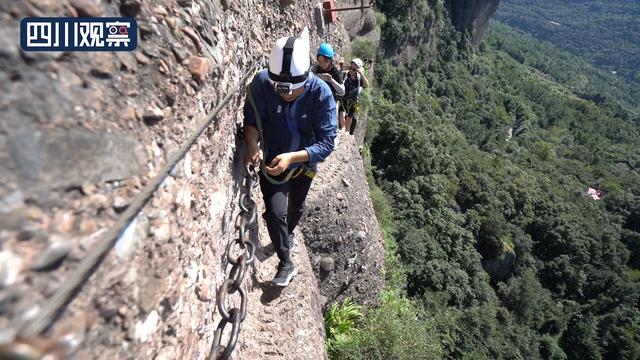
260;172;313;263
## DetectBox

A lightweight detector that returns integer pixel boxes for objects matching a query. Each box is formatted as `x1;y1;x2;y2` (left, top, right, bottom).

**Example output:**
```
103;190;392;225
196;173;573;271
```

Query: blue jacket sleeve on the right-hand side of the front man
305;84;338;163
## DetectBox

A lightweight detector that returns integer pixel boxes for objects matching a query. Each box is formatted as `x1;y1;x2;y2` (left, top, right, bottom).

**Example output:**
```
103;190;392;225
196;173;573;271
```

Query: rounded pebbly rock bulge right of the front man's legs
302;132;384;307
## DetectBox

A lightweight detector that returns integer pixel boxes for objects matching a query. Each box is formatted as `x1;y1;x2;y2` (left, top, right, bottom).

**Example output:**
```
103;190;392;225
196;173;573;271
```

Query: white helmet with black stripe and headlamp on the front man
269;37;311;93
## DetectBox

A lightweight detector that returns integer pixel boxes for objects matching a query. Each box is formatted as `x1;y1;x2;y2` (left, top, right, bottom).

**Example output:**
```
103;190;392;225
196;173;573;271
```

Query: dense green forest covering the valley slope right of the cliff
331;1;640;359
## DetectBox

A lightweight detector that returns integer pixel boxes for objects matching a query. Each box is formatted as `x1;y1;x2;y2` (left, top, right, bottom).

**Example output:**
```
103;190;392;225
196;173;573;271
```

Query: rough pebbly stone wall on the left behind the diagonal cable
0;0;358;359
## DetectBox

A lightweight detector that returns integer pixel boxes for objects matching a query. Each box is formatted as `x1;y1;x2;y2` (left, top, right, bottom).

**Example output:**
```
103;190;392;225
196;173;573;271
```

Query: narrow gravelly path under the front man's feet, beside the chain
231;209;325;360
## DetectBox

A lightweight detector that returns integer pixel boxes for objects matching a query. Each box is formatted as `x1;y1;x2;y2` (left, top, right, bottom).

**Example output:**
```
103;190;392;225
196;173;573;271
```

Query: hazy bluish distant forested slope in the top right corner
497;0;640;89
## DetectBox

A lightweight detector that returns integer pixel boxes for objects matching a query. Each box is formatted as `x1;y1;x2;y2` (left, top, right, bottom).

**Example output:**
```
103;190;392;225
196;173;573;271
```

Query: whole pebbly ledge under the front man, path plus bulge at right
237;125;384;360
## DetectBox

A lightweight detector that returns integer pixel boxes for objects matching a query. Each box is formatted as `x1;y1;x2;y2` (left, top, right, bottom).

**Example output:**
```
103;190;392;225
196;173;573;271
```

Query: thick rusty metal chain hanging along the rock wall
208;164;258;360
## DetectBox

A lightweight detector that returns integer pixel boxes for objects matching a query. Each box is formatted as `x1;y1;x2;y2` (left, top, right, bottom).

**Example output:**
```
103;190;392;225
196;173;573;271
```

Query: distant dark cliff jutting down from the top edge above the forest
446;0;500;47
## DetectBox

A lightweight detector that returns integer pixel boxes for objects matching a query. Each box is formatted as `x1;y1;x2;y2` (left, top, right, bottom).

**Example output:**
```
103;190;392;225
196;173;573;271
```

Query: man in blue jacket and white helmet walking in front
244;37;337;286
